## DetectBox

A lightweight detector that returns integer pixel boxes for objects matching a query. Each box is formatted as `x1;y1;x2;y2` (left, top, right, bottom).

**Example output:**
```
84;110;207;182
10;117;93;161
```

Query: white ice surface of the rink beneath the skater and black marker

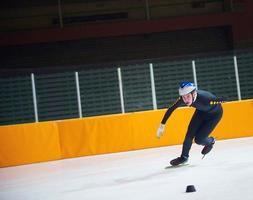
0;137;253;200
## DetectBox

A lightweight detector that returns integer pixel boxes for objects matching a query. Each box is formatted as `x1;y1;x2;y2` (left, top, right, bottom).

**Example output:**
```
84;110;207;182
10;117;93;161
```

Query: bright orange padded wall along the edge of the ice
0;100;253;167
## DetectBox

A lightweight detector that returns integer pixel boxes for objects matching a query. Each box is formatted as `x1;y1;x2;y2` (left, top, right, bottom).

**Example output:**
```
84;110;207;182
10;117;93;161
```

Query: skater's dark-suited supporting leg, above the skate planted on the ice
181;110;203;158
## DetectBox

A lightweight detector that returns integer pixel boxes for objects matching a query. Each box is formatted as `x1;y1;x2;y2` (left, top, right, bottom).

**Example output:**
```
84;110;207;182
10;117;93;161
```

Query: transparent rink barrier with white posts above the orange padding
0;50;253;125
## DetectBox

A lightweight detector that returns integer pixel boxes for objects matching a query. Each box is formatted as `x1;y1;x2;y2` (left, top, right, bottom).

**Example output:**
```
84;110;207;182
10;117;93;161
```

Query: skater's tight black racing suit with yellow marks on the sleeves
161;90;223;158
